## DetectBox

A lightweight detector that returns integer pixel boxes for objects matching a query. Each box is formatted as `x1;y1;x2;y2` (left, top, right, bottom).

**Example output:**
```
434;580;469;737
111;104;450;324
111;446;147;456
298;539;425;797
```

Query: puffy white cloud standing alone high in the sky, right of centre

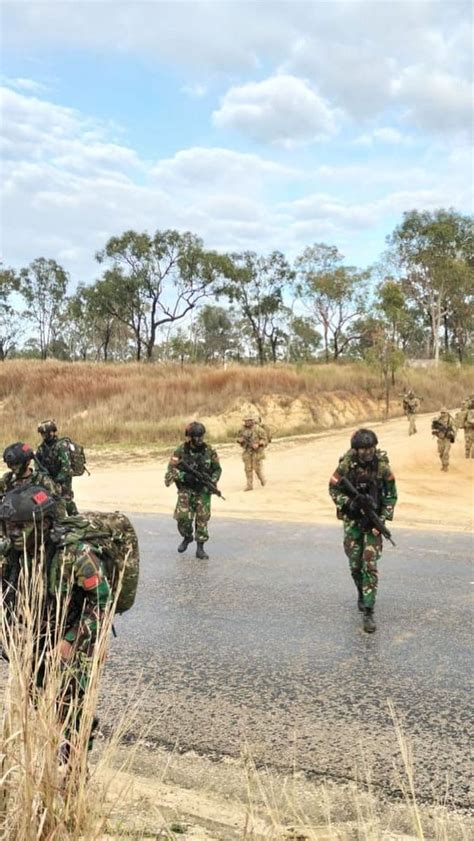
212;75;338;146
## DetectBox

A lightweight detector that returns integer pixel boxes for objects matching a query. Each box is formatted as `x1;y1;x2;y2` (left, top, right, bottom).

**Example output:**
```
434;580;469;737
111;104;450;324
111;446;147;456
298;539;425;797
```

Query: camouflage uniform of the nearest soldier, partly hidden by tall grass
0;502;112;761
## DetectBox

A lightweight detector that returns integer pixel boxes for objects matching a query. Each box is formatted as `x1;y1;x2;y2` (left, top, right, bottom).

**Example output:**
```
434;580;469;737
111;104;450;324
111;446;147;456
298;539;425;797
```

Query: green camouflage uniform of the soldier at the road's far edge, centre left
165;441;222;544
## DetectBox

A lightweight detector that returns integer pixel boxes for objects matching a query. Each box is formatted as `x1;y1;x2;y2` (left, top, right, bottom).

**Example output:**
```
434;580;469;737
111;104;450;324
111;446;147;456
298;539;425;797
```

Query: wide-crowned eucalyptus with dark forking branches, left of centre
96;230;230;360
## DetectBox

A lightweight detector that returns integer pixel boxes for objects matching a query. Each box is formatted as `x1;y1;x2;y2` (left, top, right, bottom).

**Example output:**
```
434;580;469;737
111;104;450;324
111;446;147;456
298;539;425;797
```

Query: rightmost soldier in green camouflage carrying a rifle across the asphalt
329;429;397;634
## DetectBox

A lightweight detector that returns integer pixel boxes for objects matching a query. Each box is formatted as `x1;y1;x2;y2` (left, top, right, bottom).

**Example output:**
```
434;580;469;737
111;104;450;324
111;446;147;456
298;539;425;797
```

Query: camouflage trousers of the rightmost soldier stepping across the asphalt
344;520;382;607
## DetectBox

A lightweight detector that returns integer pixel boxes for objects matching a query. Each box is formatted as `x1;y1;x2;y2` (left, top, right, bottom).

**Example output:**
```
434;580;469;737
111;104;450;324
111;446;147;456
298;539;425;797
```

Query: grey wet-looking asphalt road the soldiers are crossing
101;515;473;806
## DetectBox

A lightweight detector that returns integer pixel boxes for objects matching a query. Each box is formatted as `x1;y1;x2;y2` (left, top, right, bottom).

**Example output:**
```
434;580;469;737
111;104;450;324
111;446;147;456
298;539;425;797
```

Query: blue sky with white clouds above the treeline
0;0;474;284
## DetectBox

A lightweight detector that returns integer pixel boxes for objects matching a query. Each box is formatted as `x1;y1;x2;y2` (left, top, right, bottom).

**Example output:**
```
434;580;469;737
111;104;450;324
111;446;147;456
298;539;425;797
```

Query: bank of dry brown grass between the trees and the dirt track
0;360;472;450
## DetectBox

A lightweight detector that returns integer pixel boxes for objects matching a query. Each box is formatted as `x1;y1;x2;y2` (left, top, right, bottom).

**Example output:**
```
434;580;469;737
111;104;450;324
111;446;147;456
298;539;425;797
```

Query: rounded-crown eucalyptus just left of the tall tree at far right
295;243;370;362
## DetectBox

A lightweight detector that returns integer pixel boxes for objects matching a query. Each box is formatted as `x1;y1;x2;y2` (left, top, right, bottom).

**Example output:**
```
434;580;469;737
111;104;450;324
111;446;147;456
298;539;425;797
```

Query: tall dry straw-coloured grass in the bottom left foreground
0;541;131;841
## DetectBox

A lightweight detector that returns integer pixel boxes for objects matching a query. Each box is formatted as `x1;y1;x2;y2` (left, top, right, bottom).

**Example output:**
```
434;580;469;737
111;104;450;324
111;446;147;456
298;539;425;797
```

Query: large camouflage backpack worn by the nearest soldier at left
62;511;140;613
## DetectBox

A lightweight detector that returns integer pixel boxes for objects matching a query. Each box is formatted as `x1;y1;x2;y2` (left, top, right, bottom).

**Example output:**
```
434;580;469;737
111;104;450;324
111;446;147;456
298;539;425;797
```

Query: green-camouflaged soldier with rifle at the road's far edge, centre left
165;421;222;560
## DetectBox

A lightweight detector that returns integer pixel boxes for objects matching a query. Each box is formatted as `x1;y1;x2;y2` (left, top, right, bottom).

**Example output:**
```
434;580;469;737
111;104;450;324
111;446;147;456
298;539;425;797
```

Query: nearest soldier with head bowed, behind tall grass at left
0;484;112;763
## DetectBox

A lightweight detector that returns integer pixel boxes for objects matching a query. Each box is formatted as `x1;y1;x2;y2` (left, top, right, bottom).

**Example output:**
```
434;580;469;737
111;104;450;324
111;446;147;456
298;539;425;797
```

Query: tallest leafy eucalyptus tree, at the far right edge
387;209;474;363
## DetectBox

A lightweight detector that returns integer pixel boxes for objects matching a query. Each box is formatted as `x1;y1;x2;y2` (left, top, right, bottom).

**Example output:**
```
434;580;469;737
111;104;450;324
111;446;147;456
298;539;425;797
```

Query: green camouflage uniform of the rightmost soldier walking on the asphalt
329;449;397;609
